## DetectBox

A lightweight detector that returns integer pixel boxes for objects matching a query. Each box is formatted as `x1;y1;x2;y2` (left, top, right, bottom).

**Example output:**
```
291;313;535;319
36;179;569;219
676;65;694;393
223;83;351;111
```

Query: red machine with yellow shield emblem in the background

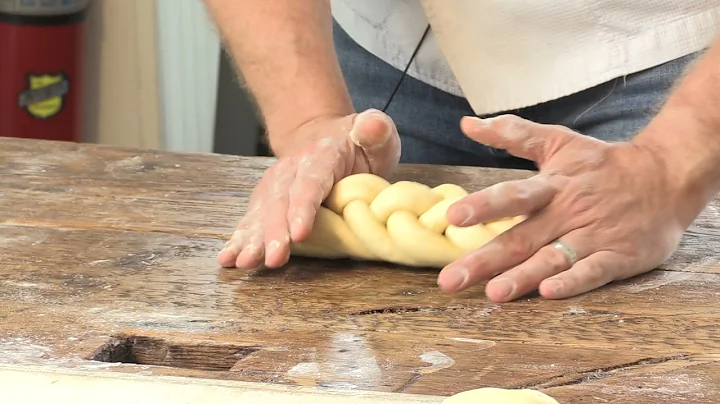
0;0;89;142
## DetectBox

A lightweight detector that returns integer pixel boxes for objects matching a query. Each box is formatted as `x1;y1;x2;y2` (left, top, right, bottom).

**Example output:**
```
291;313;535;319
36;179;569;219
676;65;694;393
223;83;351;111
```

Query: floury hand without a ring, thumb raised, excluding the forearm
218;109;400;269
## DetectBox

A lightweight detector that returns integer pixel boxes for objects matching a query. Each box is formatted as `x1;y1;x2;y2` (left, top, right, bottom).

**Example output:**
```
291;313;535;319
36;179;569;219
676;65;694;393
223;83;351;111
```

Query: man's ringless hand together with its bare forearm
205;0;400;269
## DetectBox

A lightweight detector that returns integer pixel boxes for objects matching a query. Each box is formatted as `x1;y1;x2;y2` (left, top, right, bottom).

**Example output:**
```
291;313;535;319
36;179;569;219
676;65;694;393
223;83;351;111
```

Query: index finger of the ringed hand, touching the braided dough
447;174;558;226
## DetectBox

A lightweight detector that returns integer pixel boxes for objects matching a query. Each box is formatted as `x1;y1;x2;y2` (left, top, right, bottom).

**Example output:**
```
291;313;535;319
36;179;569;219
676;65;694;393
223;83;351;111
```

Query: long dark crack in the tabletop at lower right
512;354;690;389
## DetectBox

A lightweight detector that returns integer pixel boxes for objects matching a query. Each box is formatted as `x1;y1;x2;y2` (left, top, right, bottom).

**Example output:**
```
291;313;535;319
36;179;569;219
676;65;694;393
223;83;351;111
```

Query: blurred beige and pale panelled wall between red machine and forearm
85;0;266;155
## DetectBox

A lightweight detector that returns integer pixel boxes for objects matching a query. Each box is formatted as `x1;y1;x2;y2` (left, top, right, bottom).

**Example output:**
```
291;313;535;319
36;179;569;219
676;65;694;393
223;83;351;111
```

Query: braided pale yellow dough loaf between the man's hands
292;174;523;268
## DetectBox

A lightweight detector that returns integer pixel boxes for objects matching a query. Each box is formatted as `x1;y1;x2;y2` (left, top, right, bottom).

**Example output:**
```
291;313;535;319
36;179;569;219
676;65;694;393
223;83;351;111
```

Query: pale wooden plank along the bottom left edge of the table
0;365;443;404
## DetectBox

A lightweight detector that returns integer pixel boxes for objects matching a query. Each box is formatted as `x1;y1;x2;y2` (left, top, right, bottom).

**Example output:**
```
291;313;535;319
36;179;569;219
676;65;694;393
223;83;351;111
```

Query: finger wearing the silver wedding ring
485;229;595;303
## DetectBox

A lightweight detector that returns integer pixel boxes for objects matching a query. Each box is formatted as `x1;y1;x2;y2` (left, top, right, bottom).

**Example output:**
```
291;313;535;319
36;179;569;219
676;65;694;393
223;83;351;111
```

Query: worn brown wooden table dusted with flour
0;138;720;404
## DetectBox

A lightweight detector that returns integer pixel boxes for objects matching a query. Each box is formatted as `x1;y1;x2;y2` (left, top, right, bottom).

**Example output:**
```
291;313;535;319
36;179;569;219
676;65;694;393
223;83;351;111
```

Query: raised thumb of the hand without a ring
349;109;401;177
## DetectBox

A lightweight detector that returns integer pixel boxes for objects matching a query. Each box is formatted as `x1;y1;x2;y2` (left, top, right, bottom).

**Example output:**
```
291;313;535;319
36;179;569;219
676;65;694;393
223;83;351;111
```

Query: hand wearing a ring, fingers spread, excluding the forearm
438;115;703;302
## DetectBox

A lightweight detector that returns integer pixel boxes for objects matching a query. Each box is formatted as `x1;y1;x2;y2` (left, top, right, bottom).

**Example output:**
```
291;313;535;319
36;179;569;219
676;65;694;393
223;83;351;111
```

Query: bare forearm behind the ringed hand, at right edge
634;36;720;207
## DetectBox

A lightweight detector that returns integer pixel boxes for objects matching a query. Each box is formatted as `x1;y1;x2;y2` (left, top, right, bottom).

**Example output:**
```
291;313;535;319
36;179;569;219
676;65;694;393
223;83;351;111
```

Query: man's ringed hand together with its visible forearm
438;38;720;302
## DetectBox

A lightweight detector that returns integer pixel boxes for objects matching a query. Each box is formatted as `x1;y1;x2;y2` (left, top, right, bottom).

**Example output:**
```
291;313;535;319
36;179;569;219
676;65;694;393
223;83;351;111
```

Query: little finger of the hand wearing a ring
539;251;638;299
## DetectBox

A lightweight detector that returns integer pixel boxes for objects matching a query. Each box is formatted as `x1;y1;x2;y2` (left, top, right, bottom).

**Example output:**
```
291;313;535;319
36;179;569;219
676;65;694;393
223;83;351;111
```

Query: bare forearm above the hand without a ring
205;0;353;154
